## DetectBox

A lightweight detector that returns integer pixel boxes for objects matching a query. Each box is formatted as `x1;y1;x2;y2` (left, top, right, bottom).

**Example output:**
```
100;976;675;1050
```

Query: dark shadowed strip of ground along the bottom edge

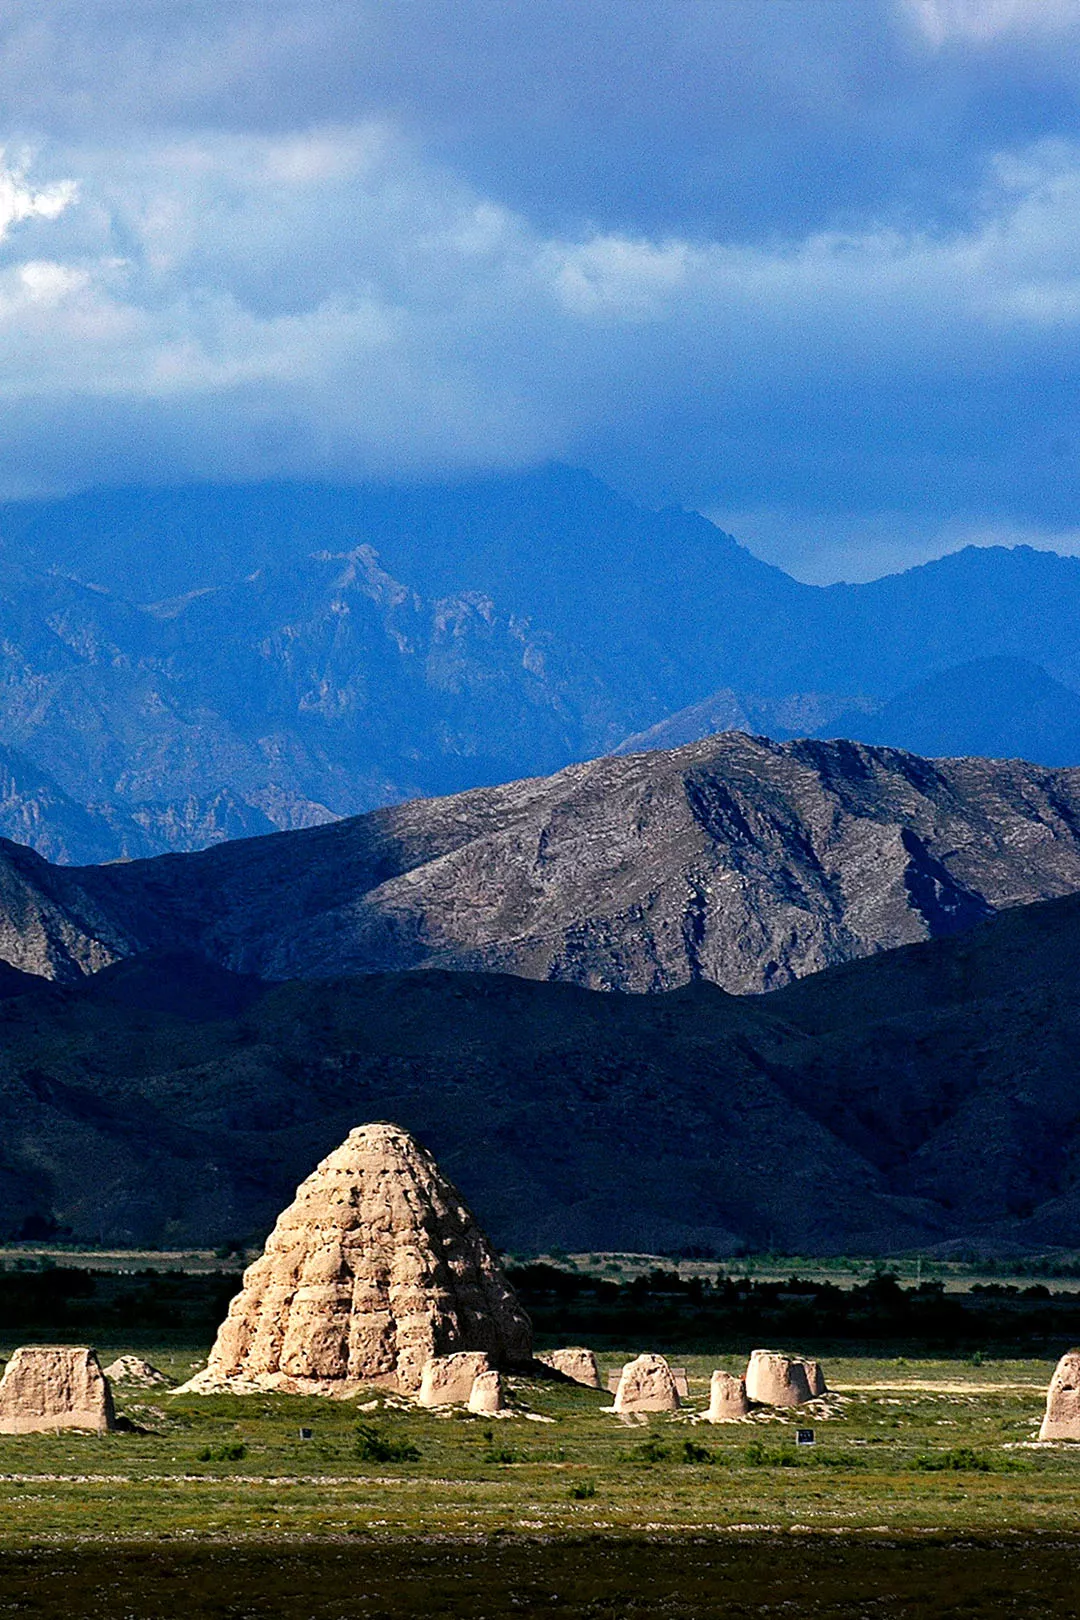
0;1534;1080;1620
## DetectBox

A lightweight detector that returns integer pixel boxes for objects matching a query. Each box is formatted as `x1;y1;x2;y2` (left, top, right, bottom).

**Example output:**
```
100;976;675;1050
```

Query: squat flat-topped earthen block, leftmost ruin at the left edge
0;1345;117;1434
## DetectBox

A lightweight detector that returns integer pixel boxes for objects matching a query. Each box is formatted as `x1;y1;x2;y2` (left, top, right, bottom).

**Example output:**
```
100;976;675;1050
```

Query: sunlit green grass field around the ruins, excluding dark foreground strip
0;1348;1080;1547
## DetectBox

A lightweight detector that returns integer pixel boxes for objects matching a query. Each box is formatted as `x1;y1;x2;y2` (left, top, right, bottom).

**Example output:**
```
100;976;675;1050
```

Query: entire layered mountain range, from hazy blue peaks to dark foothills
0;470;1080;1254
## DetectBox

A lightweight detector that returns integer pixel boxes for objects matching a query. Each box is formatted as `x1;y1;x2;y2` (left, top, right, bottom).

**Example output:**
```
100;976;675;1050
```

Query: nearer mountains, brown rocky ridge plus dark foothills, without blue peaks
0;732;1080;1254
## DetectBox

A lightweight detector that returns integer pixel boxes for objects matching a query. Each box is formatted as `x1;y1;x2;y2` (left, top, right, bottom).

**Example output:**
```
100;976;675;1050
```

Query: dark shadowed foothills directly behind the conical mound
0;896;1080;1254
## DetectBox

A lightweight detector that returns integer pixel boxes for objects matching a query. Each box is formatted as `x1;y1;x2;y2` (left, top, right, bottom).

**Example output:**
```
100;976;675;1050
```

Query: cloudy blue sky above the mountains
0;0;1080;582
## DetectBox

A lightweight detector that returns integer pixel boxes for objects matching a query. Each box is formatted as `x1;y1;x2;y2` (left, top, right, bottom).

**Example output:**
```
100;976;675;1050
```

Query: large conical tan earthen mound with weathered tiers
193;1124;531;1393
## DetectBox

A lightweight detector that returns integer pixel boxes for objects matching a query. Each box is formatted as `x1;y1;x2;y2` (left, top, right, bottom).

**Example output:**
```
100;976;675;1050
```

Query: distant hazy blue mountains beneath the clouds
0;467;1080;862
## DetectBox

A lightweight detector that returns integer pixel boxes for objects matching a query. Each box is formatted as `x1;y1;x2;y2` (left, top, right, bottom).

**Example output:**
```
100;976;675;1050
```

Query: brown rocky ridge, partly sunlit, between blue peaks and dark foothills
0;732;1080;993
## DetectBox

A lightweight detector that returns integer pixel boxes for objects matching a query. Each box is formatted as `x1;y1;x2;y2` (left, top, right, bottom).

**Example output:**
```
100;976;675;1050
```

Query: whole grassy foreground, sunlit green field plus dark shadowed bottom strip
0;1335;1080;1620
